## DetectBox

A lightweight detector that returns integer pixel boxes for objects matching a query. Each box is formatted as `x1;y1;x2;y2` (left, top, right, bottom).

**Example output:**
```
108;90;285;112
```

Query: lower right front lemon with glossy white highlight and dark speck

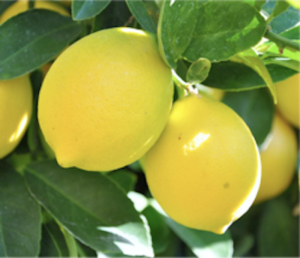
144;96;261;234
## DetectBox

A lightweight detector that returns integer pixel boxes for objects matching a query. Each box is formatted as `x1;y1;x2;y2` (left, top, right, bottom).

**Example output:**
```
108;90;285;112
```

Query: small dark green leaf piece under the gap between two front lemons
107;169;137;193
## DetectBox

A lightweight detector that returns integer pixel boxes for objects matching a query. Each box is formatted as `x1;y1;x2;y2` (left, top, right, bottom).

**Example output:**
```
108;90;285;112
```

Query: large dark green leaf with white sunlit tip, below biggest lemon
25;161;153;257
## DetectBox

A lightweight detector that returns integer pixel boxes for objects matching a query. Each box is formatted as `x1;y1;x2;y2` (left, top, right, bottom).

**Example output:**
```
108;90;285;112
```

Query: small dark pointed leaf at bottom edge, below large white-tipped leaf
39;221;70;258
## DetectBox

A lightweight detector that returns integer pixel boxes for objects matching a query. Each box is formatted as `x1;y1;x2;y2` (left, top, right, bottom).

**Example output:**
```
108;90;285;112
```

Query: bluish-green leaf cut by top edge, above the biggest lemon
72;0;110;21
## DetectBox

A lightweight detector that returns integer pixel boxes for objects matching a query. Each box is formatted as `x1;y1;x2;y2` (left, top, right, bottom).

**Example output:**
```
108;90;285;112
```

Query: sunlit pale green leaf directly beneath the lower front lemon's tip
166;218;233;258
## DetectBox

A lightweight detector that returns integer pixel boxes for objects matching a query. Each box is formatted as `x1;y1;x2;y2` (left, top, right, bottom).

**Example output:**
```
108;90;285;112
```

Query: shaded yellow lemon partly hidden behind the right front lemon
255;115;298;203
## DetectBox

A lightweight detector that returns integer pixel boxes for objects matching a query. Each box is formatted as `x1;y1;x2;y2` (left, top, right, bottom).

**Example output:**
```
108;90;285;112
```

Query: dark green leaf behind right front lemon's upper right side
222;88;274;145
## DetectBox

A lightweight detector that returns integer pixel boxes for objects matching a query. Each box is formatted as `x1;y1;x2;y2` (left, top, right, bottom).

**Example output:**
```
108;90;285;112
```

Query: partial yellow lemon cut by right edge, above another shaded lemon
275;73;300;128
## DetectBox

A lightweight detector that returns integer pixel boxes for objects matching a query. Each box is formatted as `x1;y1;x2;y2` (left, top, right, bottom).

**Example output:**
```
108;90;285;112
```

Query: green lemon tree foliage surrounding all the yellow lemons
0;0;300;258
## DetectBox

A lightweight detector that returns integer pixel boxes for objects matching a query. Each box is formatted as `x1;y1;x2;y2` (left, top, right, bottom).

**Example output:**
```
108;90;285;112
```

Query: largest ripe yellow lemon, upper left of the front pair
38;28;173;171
